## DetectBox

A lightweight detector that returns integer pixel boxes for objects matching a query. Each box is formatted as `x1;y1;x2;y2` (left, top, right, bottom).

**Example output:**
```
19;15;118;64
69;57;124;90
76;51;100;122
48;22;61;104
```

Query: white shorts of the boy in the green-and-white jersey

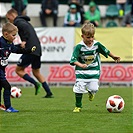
73;81;99;94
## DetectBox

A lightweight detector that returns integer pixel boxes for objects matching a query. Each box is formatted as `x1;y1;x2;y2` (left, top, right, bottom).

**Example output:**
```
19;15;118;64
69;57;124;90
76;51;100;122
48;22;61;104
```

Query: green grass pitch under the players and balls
0;87;133;133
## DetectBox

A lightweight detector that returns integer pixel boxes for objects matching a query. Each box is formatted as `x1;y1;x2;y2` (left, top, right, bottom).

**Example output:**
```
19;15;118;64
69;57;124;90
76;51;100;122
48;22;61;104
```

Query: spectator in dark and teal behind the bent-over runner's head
11;0;28;15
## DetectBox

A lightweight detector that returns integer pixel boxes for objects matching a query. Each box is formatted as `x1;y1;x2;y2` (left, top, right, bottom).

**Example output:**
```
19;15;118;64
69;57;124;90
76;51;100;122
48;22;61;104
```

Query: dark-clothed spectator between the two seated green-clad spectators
68;0;85;24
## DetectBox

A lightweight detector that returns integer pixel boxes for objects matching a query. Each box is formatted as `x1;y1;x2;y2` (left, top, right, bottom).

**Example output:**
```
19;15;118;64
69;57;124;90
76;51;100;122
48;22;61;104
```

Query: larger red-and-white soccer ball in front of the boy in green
106;95;125;112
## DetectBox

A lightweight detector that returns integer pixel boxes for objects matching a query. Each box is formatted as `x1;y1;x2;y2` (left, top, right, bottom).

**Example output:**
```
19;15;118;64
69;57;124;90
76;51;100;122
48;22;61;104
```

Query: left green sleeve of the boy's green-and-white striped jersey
70;45;81;66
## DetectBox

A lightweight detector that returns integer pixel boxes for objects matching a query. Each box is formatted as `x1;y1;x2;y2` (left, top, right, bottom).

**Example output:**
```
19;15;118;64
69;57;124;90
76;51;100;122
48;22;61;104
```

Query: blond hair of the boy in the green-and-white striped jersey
81;22;95;35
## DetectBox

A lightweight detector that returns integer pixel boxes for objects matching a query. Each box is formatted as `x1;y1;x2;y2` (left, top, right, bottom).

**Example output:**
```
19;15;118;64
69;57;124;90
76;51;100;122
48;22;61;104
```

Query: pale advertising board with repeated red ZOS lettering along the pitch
6;63;133;86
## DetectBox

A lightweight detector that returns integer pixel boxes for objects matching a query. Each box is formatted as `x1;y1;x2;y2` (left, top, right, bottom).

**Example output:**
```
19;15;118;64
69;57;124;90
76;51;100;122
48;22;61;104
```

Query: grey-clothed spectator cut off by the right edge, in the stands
122;3;133;27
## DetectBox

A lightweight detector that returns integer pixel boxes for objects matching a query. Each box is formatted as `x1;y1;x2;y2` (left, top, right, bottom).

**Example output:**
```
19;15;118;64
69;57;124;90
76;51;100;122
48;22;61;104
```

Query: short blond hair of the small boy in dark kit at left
2;22;18;34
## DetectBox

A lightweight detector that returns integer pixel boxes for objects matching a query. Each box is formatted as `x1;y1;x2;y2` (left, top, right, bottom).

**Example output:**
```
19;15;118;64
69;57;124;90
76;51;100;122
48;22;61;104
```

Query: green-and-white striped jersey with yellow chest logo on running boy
70;40;110;82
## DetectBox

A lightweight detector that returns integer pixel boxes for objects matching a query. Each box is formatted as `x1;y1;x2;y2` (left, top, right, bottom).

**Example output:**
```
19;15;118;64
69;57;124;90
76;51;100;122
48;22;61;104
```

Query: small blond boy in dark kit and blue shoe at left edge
0;23;36;112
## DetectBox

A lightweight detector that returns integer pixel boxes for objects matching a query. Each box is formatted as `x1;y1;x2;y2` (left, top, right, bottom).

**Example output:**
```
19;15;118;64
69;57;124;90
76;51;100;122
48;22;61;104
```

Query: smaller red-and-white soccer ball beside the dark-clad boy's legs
11;86;22;98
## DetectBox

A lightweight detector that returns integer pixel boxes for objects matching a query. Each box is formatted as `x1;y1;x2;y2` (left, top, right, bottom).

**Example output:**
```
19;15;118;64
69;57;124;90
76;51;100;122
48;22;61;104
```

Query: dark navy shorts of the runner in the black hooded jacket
17;54;41;69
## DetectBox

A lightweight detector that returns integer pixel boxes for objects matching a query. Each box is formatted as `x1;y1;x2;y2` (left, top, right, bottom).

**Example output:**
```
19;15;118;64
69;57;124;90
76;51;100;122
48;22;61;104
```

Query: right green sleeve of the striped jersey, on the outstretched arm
98;42;110;58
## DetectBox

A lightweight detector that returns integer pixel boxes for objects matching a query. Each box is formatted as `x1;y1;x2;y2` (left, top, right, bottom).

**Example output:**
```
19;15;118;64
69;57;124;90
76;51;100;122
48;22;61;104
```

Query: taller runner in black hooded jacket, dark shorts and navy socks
6;9;53;98
